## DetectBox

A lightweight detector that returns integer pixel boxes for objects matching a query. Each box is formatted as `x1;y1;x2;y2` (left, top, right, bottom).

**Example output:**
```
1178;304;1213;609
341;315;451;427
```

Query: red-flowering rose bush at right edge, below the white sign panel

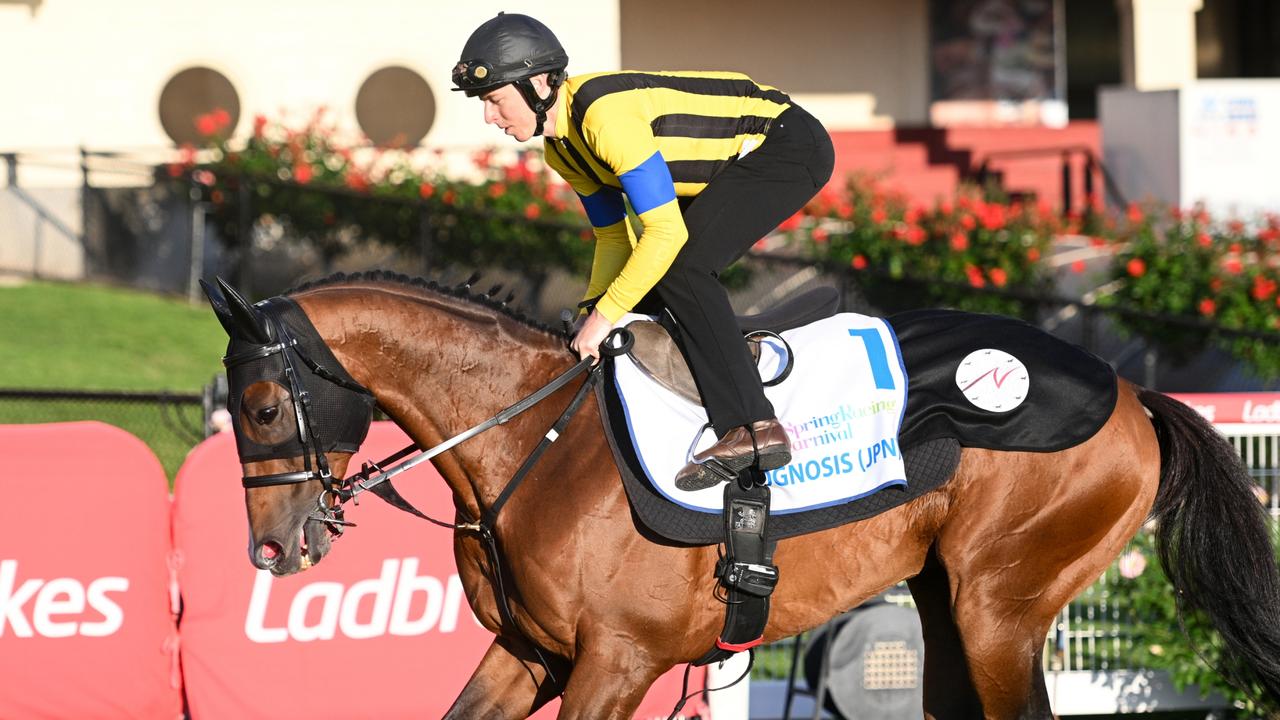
1105;205;1280;375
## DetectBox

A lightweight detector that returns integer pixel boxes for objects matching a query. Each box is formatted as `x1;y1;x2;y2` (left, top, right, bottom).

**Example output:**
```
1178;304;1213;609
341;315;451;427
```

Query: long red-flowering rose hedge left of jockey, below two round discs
168;110;591;278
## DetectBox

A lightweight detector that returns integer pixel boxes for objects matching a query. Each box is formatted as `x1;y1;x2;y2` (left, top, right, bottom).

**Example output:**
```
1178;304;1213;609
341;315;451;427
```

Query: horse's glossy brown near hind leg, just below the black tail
937;389;1160;720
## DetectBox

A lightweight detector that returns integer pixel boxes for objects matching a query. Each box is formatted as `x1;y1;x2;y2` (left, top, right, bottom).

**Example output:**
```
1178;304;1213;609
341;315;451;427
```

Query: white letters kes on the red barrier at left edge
0;560;129;638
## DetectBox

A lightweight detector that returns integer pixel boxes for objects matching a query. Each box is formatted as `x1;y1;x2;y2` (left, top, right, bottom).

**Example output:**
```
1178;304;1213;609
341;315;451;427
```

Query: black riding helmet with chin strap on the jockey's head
453;13;568;135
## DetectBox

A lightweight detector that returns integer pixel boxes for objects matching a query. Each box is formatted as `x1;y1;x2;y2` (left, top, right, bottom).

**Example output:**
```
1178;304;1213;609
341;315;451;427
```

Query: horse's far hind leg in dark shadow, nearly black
906;540;982;720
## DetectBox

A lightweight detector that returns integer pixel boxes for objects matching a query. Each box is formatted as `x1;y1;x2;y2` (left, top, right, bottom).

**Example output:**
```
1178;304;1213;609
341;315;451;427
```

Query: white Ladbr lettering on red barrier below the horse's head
244;557;480;643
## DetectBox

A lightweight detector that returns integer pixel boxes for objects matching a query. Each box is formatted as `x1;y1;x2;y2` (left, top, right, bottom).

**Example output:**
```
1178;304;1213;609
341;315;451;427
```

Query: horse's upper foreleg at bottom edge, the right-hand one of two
557;642;668;720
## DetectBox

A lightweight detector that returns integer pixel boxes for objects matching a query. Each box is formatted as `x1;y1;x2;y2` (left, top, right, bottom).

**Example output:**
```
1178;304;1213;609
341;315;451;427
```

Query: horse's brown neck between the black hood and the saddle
299;288;571;518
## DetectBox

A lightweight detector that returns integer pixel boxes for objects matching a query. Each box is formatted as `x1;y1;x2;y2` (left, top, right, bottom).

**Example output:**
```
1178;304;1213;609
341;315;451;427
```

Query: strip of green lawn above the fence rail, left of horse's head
0;282;227;392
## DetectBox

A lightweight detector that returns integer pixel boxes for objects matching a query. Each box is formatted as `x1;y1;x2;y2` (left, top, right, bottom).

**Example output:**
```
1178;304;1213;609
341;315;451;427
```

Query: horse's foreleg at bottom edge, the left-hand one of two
444;638;570;720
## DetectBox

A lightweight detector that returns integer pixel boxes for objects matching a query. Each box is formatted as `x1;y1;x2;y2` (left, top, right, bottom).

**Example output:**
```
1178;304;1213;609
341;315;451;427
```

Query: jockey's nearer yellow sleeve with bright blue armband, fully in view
582;113;689;322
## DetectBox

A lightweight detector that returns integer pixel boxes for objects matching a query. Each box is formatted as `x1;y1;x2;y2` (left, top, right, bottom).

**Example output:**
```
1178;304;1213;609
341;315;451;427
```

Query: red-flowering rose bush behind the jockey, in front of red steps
781;176;1062;315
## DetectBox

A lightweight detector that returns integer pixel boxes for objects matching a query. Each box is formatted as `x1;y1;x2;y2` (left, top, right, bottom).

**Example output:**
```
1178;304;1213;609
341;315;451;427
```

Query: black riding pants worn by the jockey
636;106;835;436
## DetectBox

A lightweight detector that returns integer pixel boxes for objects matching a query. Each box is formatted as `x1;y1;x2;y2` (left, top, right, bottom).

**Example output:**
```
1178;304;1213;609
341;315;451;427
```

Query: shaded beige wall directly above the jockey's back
616;0;929;129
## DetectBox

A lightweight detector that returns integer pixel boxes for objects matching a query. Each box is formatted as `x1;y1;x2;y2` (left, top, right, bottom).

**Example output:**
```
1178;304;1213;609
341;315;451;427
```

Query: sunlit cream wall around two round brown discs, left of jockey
0;0;620;184
